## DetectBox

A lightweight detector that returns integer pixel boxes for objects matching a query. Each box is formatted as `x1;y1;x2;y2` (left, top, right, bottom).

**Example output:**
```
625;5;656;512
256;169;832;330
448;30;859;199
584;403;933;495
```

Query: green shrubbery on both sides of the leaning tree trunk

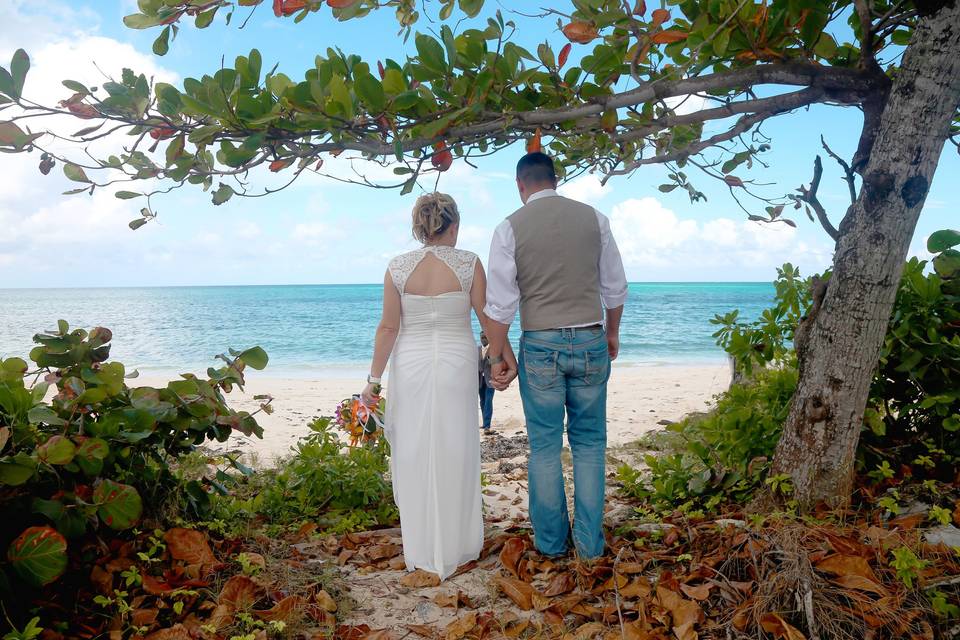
620;231;960;509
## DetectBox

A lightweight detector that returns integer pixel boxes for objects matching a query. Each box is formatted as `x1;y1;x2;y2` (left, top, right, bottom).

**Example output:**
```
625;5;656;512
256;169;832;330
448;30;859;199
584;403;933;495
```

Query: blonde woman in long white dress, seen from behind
361;193;516;580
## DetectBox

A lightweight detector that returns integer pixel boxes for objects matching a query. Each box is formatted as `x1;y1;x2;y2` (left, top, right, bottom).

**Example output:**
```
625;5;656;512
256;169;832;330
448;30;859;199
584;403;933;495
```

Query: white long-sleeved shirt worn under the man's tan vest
483;189;627;329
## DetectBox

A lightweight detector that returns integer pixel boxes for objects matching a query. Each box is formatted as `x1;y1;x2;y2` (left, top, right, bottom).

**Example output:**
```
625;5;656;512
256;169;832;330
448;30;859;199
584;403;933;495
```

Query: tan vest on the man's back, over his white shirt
507;196;603;331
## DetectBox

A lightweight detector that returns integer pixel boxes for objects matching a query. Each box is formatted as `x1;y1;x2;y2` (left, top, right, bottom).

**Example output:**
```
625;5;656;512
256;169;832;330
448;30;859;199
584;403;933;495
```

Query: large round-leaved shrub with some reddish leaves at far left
0;320;269;588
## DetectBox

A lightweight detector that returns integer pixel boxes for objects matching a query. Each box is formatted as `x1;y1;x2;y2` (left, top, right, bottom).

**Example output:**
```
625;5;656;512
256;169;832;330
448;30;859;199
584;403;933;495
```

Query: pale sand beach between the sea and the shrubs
141;364;730;464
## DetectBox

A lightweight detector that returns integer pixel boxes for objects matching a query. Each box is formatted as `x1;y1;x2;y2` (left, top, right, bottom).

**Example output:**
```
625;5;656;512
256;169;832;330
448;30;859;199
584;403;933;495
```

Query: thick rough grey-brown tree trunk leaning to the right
772;0;960;509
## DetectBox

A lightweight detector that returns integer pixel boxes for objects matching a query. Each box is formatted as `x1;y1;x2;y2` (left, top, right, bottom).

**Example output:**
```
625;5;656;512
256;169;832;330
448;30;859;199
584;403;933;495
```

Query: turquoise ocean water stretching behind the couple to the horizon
0;282;774;378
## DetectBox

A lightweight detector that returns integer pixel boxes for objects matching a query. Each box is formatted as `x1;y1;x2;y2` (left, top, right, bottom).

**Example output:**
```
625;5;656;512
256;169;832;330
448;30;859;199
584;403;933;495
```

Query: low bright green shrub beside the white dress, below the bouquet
214;418;398;534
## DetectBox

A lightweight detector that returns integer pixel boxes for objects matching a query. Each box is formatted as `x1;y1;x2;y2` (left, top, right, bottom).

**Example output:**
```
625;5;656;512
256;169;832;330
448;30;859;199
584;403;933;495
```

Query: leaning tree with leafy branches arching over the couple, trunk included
0;0;960;506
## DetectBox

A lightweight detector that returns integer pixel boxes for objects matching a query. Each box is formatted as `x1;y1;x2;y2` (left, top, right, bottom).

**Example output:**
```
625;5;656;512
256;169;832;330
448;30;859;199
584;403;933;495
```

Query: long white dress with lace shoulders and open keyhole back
384;246;483;579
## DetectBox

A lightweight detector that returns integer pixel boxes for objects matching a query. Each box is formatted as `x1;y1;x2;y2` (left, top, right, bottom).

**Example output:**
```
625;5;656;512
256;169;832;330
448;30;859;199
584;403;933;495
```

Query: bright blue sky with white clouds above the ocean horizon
0;0;960;287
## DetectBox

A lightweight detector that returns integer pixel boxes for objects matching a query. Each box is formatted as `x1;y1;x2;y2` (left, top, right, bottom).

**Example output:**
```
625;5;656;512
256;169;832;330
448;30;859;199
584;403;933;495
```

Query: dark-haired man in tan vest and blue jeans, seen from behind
485;153;627;559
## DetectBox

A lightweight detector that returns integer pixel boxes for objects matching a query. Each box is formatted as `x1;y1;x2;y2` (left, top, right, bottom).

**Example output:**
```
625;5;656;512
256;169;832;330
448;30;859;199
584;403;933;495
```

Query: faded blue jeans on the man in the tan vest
519;327;610;558
